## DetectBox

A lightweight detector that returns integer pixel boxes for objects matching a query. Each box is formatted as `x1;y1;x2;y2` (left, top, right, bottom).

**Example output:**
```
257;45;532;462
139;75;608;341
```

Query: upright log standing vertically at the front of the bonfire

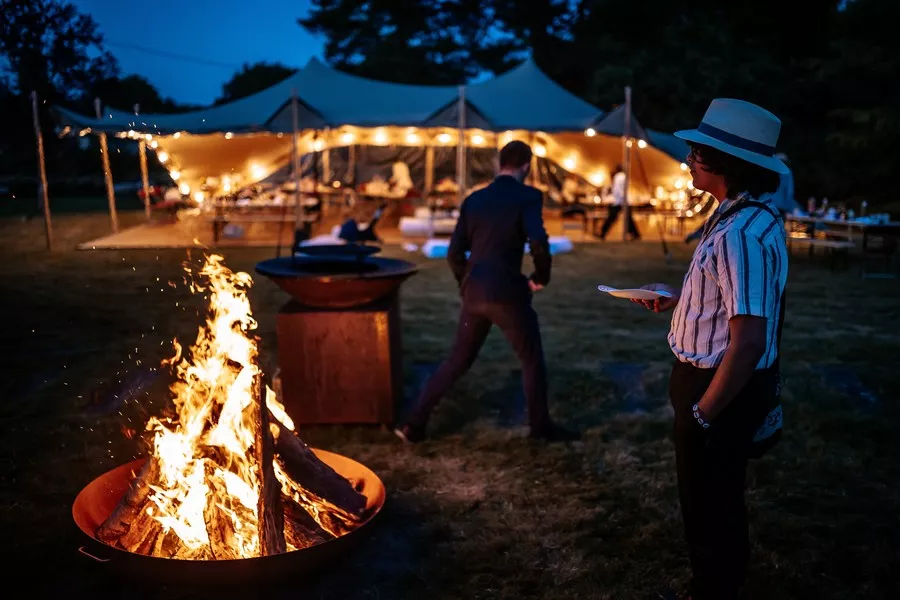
253;374;286;556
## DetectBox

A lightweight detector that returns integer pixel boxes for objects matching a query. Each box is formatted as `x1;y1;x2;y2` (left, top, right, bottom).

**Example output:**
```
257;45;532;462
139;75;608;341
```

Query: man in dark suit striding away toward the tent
395;141;579;442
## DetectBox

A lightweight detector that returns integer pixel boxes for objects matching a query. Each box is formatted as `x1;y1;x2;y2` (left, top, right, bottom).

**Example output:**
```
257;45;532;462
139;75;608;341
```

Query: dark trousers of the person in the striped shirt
669;362;774;600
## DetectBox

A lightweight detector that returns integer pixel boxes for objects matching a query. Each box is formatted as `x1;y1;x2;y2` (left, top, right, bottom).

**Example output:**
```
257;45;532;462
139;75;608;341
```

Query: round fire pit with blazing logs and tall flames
72;256;385;583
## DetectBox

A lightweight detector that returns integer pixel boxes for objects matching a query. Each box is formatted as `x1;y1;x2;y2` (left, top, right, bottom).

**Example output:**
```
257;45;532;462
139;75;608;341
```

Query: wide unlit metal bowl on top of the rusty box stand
256;256;418;308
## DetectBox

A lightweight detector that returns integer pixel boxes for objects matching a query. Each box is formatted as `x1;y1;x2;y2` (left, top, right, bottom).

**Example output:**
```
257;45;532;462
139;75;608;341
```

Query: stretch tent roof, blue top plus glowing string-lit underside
56;59;687;202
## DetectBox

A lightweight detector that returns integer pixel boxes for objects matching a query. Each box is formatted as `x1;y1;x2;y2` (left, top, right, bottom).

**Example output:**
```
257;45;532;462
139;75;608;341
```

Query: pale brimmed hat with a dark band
675;98;790;175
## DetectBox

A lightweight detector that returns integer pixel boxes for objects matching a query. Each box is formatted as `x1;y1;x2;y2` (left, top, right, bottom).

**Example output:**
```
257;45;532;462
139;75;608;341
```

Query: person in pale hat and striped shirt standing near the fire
642;99;788;600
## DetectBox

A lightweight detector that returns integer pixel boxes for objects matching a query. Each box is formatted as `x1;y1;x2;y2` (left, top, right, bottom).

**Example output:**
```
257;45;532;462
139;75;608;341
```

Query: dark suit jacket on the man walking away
447;175;551;304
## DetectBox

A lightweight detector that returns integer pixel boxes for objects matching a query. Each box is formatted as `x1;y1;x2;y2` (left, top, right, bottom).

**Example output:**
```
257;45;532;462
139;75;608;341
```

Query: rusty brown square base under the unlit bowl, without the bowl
277;293;403;424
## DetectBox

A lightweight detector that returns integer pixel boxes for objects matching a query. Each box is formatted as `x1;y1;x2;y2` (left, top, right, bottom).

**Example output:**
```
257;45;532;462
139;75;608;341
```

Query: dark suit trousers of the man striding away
409;302;550;431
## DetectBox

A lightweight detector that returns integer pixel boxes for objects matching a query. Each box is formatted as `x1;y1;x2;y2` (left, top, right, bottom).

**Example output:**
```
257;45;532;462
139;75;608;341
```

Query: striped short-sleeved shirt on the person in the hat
669;194;788;369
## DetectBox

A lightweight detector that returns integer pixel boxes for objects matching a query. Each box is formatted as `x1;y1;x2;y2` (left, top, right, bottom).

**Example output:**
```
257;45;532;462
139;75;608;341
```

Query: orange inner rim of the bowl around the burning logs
72;447;387;565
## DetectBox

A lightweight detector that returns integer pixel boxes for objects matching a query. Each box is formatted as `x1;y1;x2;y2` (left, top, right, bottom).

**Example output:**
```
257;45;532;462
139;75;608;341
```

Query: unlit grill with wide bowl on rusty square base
256;244;418;424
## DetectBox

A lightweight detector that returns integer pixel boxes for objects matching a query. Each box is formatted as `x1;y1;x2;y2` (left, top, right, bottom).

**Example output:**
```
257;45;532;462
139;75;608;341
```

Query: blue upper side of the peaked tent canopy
57;58;602;135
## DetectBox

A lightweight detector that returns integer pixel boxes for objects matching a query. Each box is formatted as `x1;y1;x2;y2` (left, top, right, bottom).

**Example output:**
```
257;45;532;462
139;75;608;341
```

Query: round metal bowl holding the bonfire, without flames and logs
72;448;385;585
